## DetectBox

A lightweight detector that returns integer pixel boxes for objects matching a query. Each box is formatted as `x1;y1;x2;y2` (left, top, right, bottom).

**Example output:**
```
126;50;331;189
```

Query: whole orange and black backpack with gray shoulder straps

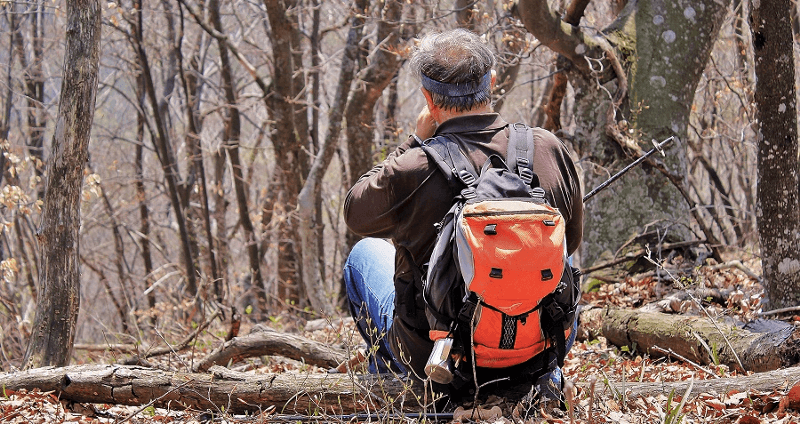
423;124;580;378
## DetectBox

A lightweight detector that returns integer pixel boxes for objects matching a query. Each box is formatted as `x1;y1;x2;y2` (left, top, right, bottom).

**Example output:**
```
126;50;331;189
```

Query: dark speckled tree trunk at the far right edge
750;0;800;309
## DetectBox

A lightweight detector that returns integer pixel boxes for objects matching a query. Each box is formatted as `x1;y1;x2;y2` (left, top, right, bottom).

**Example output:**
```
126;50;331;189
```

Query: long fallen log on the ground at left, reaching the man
0;365;424;415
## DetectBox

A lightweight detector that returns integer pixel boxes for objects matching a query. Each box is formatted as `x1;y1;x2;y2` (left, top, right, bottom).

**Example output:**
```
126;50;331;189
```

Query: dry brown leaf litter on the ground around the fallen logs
0;253;800;424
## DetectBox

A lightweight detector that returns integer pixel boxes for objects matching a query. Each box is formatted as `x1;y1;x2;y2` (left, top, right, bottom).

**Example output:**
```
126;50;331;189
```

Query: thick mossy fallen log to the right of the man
592;308;800;372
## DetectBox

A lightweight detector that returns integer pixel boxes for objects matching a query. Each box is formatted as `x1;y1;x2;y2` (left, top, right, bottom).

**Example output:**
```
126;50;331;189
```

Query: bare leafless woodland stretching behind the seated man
0;0;800;380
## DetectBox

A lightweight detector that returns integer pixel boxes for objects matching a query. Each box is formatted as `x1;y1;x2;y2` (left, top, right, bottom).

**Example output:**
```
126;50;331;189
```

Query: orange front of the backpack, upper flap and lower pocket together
456;199;565;368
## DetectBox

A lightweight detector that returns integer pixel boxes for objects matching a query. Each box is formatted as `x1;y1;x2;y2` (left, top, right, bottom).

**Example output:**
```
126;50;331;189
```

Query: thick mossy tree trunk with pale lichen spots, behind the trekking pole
519;0;729;265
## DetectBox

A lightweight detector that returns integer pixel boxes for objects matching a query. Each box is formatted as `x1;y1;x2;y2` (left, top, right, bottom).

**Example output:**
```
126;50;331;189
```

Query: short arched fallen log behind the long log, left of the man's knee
193;326;348;372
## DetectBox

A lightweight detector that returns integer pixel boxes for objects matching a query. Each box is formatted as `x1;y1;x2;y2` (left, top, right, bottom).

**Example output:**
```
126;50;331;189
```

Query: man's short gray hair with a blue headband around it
410;28;495;112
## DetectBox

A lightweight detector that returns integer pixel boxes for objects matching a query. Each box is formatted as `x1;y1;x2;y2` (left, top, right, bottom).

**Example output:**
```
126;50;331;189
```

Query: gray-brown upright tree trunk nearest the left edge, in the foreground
23;0;102;368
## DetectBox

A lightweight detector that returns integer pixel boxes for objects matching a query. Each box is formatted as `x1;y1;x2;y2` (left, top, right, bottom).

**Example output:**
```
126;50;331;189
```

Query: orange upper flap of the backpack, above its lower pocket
456;199;565;316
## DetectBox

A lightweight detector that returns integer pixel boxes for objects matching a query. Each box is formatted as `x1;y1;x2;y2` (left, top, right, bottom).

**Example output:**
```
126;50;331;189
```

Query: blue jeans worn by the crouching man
344;238;578;389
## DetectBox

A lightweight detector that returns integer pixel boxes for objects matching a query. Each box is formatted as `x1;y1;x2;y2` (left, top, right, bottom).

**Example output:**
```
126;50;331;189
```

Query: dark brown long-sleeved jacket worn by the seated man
344;113;583;377
